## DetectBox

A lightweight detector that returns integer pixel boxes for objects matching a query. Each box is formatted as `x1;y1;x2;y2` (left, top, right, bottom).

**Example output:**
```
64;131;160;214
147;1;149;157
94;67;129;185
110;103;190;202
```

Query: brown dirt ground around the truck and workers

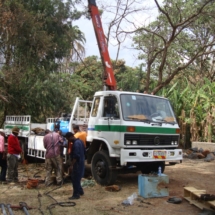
0;159;215;215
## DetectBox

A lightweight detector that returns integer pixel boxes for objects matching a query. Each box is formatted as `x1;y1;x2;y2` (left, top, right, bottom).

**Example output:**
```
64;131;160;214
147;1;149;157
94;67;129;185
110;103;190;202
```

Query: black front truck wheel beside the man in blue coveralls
91;151;117;185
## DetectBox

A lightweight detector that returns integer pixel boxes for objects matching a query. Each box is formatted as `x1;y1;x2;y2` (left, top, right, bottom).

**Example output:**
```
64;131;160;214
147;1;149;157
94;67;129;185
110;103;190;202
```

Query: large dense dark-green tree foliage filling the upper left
0;0;84;121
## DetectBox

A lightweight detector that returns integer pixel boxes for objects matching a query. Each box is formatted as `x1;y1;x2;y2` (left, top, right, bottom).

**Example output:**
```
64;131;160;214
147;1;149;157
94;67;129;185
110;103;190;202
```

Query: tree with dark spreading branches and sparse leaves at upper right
134;0;215;93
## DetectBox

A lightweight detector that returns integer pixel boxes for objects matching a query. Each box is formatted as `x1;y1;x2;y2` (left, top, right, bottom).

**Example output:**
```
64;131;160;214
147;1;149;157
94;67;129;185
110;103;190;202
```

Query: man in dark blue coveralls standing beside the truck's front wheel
66;132;85;200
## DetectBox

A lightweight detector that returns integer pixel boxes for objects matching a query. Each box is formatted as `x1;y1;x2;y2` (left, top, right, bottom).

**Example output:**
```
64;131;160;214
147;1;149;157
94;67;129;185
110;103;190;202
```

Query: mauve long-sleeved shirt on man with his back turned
43;132;62;158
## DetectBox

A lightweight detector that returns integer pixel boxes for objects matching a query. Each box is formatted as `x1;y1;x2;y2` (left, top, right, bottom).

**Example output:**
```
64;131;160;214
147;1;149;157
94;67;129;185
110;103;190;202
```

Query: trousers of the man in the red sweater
7;154;18;181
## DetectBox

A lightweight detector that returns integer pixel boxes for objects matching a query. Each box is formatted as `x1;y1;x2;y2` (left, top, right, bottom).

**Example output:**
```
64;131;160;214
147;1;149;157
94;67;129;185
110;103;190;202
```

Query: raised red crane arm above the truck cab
88;0;116;90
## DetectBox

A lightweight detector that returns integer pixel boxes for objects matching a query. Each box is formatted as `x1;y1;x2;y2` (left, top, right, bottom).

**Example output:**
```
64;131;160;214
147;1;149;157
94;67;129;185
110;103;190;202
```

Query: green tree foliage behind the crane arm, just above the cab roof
71;56;143;100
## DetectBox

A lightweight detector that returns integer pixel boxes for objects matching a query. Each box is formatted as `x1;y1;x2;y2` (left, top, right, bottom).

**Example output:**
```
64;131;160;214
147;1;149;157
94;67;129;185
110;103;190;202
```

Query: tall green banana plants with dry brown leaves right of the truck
158;76;215;142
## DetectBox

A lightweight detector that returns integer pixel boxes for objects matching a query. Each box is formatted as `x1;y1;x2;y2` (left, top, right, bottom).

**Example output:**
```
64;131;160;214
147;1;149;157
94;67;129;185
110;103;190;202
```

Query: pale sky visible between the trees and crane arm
74;0;160;67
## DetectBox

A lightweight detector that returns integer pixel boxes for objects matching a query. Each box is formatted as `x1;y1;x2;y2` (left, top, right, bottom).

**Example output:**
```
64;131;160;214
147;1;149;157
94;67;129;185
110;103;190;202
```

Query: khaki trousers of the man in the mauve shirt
45;155;63;186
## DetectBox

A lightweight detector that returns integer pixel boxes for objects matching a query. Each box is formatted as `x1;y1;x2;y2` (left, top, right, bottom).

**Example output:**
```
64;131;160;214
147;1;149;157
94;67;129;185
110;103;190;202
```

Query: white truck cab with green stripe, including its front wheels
77;91;182;185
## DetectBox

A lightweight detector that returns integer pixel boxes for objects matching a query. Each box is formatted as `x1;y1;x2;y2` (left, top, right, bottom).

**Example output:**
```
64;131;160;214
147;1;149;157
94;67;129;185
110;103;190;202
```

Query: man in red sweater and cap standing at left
7;126;22;182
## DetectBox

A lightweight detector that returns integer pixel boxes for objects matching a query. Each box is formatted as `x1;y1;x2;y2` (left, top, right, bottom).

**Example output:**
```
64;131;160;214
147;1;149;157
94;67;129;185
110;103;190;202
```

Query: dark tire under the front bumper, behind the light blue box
140;161;165;174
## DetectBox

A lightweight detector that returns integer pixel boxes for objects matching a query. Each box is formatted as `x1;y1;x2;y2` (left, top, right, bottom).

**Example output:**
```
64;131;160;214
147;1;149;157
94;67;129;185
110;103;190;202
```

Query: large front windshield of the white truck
121;94;176;124
